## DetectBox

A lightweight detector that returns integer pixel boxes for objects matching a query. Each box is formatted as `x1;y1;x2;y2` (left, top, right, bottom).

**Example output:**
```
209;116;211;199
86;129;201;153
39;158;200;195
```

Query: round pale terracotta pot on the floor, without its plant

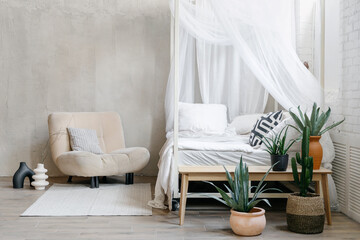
230;207;266;236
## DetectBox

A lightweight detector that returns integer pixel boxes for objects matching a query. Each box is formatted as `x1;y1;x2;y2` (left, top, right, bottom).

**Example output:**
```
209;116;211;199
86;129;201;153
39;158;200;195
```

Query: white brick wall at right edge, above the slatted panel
332;0;360;135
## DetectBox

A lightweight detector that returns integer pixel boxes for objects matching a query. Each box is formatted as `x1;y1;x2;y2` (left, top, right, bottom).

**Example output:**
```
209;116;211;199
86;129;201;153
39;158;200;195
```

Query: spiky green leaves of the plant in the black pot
263;126;297;155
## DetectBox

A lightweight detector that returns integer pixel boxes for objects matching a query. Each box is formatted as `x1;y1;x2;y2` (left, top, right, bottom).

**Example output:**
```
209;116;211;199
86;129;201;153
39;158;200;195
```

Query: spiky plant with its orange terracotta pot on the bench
289;103;345;170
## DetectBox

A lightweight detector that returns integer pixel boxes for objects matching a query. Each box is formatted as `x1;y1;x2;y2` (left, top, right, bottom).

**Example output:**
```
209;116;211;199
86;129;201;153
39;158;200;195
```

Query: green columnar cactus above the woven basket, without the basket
291;126;313;197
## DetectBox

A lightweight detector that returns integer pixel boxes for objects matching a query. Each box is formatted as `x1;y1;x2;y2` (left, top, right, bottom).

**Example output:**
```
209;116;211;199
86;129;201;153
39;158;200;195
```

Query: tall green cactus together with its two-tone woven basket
286;126;325;234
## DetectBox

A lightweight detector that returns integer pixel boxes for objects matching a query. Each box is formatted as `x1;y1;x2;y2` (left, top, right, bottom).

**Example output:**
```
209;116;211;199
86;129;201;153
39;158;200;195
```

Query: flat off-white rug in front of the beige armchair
21;183;152;216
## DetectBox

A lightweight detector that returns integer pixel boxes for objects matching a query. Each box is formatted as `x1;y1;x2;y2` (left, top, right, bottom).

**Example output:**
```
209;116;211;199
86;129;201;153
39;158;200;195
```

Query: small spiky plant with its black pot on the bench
263;126;296;171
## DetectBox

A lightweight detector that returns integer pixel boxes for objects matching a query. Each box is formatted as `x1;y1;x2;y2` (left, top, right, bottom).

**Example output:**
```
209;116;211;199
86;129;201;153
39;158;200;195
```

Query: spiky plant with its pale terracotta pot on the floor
208;157;280;236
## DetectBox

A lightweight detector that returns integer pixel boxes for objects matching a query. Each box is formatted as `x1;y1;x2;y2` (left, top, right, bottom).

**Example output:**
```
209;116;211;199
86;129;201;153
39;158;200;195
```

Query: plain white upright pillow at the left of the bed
179;102;227;134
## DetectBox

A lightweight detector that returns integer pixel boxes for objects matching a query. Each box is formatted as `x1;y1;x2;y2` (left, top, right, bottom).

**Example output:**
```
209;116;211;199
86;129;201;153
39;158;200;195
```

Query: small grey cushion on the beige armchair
67;128;103;154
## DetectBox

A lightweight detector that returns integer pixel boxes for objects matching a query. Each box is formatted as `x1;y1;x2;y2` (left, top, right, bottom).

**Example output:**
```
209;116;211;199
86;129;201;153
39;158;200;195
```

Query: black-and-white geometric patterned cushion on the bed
249;111;282;148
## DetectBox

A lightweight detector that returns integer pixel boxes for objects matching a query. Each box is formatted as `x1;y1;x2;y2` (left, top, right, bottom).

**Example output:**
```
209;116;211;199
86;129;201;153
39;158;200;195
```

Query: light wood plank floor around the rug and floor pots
0;177;360;240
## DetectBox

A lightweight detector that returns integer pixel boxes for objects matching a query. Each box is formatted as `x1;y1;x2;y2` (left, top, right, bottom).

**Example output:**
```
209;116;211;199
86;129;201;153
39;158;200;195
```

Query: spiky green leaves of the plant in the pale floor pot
208;157;280;212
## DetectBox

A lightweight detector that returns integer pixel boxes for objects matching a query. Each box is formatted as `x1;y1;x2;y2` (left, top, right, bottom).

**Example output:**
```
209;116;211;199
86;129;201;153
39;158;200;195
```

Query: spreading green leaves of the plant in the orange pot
289;103;345;136
